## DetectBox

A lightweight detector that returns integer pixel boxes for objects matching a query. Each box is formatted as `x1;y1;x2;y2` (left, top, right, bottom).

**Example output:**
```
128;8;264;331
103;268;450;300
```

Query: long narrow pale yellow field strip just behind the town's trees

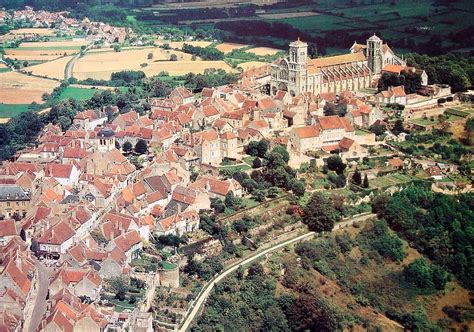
74;60;235;80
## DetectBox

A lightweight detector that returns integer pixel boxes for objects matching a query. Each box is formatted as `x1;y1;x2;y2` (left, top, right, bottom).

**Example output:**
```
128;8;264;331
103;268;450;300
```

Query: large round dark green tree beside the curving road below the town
303;192;336;232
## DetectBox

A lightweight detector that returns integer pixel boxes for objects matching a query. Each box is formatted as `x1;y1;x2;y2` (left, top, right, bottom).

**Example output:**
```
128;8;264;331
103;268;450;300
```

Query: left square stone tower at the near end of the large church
288;38;308;96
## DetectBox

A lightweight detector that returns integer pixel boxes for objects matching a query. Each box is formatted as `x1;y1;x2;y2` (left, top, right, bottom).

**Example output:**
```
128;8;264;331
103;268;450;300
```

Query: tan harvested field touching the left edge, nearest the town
0;72;59;104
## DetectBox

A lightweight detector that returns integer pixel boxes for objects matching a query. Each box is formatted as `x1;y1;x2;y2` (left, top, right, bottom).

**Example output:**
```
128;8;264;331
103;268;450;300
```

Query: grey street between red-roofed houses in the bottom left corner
24;261;49;332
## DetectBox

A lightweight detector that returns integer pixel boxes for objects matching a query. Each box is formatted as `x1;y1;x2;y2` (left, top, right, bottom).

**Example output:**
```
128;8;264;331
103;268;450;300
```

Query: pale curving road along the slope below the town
180;213;375;332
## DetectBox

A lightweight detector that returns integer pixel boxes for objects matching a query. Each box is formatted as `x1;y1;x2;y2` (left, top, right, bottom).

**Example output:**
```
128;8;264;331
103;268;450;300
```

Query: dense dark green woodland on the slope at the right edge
373;185;474;290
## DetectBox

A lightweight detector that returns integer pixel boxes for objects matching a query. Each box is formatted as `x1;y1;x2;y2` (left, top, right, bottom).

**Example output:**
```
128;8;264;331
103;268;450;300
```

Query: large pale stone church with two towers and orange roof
270;35;406;96
